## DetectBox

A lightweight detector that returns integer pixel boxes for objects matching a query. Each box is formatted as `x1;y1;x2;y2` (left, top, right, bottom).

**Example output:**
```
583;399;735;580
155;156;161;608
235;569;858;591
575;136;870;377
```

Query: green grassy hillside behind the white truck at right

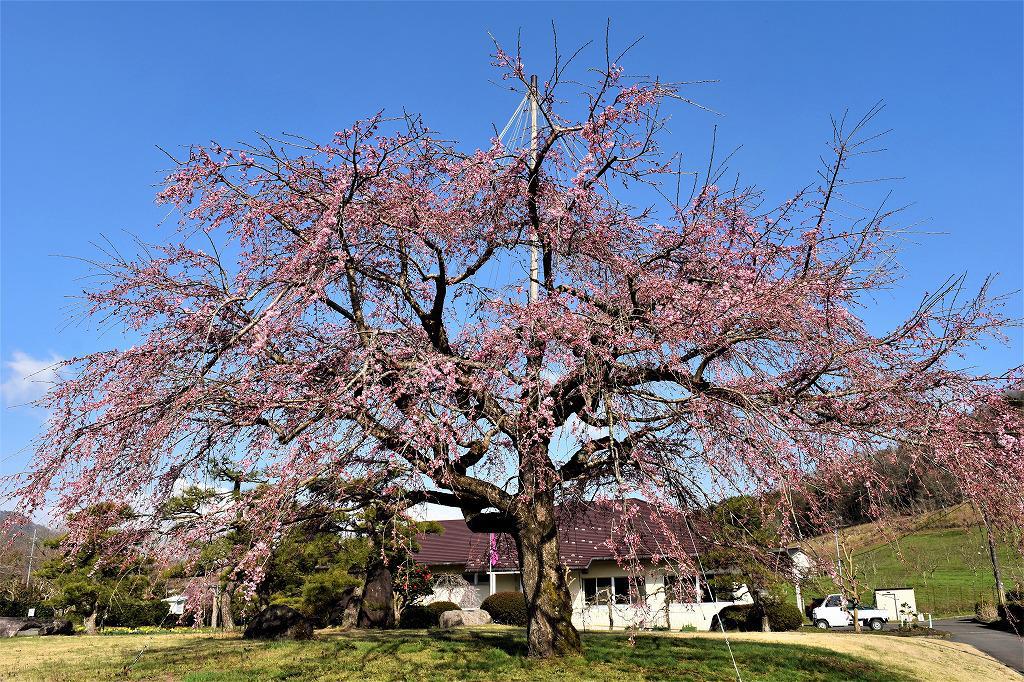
806;505;1024;616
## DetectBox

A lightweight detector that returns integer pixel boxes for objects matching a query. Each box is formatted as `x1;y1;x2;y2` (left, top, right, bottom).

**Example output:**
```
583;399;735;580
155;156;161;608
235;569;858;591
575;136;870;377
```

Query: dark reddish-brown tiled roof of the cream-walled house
416;500;705;571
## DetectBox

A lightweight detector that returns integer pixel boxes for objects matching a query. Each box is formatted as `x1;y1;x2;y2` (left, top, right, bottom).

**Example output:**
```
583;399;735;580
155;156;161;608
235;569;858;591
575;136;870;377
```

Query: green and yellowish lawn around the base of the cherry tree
0;627;911;682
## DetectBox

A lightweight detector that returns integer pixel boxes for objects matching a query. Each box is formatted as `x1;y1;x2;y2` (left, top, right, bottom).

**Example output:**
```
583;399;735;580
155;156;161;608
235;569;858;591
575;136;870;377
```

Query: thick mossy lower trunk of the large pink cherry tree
516;512;583;658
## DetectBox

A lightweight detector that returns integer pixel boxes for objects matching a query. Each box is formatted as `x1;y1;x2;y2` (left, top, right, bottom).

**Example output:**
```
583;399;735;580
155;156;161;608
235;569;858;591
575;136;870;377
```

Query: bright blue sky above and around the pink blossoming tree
0;2;1024;483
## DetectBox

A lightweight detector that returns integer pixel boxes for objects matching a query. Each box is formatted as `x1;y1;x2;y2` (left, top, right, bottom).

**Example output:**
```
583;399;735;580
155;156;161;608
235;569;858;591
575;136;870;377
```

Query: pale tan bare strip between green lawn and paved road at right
672;632;1024;682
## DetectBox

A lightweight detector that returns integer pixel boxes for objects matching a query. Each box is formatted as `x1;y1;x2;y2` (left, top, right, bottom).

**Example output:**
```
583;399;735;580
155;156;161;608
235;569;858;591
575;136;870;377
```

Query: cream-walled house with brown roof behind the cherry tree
416;499;752;630
